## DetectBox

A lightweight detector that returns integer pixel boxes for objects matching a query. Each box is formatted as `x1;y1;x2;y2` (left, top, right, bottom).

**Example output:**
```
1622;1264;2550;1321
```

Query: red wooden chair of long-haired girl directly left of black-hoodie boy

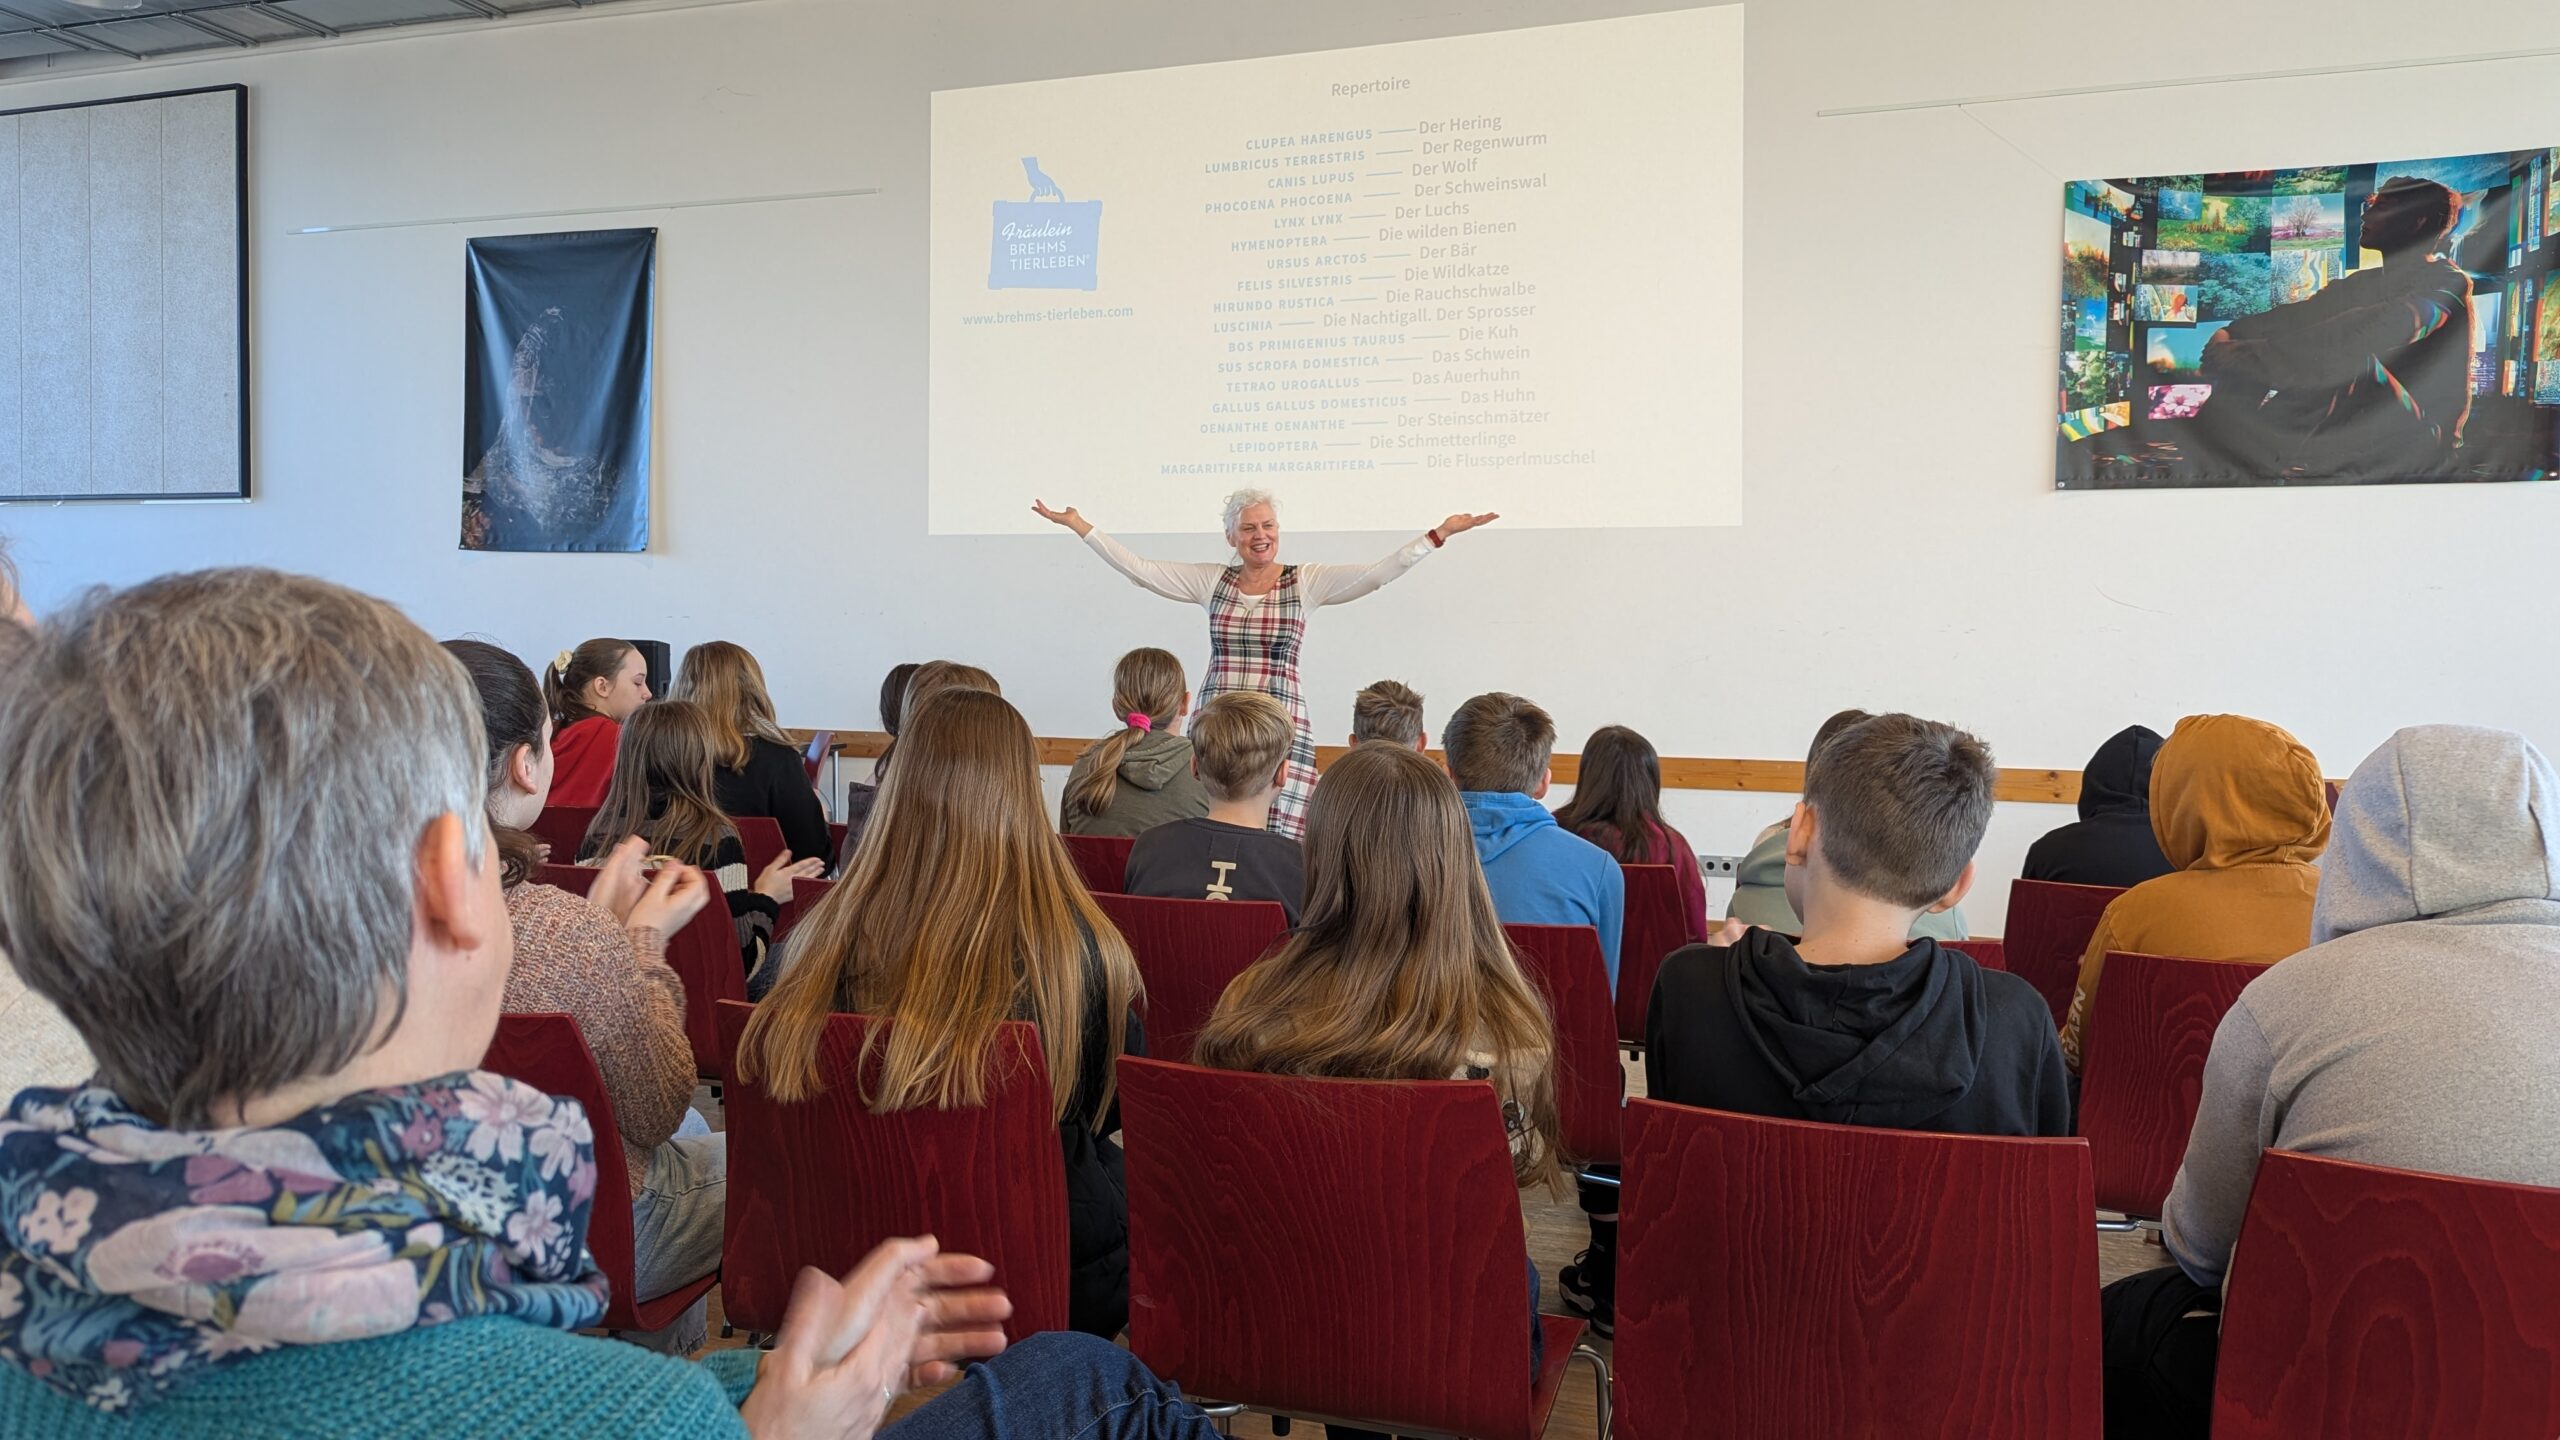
1119;1058;1597;1440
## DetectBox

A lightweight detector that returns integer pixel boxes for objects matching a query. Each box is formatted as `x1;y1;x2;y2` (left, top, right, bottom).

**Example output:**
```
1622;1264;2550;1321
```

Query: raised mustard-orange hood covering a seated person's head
2150;715;2330;871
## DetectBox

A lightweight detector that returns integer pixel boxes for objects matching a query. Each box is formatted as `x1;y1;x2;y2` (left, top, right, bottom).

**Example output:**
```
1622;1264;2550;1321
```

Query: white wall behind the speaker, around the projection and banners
0;0;2560;928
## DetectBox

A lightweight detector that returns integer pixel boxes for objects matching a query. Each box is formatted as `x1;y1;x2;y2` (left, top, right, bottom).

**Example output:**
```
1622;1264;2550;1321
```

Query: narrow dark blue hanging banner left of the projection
463;231;658;553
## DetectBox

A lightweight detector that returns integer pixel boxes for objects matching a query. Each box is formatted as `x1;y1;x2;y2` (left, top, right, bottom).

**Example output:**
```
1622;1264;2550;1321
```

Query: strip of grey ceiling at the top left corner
0;0;670;79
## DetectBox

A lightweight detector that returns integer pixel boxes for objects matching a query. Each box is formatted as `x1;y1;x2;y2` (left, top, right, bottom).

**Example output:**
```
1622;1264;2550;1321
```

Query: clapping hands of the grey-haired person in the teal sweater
737;1235;1014;1440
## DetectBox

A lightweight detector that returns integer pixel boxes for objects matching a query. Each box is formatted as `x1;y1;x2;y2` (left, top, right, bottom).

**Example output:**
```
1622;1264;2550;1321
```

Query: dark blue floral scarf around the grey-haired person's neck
0;1071;604;1412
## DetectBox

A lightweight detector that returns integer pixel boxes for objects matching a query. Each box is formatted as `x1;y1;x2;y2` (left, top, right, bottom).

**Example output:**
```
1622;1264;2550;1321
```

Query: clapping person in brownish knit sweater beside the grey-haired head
445;641;730;1355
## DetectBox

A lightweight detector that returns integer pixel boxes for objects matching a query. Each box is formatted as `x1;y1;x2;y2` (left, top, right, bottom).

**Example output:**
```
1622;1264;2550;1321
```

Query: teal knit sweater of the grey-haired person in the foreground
0;1317;755;1440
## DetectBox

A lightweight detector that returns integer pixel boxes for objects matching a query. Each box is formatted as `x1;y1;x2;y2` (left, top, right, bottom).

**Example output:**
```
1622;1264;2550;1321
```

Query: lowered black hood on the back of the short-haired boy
1725;930;1989;1130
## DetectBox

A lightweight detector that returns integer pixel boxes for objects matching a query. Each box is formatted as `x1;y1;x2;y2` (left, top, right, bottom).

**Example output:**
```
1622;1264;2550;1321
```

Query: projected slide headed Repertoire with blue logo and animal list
929;5;1746;533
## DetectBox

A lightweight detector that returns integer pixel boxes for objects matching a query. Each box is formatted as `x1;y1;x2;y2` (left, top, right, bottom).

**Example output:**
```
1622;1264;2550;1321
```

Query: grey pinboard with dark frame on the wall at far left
0;85;248;505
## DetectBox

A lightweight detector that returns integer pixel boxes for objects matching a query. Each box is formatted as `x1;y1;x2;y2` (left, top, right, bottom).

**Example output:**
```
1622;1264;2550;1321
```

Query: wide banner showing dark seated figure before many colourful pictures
2056;149;2560;489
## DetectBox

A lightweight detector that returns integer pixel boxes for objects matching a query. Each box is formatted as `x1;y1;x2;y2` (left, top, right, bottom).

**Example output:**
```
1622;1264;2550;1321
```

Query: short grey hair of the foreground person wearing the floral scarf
0;569;489;1130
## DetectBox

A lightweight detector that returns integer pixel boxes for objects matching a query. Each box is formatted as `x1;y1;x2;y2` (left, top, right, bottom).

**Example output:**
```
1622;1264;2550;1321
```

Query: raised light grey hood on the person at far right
2312;725;2560;945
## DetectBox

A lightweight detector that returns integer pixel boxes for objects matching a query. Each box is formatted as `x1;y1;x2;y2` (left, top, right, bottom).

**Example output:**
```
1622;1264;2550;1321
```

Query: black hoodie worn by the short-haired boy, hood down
1644;930;2071;1135
